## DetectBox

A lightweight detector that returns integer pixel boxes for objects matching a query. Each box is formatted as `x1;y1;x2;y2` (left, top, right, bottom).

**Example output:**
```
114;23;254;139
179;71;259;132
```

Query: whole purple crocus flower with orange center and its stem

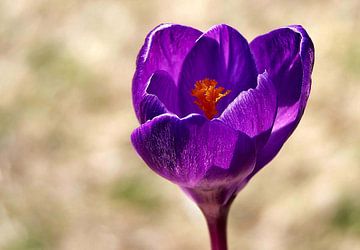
131;24;314;250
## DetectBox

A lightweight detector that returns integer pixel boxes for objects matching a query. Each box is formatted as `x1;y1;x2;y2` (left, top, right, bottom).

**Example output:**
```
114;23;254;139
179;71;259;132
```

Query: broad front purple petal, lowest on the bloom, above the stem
131;115;255;188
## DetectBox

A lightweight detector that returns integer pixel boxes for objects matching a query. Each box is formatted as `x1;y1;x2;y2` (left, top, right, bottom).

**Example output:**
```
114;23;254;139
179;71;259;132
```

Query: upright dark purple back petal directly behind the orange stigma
179;24;257;116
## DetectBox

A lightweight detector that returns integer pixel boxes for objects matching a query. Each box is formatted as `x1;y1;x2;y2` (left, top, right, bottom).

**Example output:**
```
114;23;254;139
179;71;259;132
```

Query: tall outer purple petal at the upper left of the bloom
132;24;202;121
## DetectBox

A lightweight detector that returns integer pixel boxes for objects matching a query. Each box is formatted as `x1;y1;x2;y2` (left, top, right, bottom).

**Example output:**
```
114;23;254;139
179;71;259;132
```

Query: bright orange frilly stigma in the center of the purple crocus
191;78;230;120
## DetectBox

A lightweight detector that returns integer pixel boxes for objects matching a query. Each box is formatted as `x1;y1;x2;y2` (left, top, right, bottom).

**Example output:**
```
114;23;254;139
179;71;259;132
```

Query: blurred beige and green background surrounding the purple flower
0;0;360;250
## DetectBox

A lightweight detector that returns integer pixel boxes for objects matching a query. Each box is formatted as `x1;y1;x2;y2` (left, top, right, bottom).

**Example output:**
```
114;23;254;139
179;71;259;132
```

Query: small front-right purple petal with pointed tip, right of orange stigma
219;72;277;149
